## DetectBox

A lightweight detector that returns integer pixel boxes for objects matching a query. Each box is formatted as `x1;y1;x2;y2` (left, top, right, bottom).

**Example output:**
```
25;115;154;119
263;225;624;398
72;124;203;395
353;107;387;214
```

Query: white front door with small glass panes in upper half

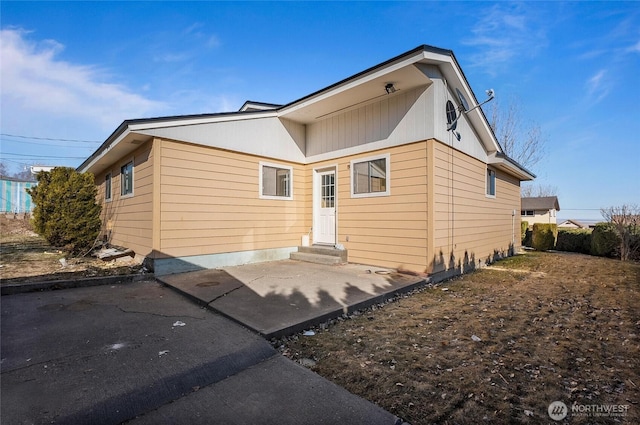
313;170;336;245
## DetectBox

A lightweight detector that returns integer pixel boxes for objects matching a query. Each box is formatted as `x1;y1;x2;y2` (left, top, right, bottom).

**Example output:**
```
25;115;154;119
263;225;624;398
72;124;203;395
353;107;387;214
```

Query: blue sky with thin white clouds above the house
0;1;640;219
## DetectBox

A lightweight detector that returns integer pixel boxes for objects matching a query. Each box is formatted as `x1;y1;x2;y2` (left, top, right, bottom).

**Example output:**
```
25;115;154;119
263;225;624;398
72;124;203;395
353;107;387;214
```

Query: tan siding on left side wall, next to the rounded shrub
96;142;153;256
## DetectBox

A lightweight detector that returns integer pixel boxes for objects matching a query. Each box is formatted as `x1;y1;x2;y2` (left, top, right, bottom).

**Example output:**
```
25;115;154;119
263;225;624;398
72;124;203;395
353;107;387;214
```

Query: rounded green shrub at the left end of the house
28;167;101;254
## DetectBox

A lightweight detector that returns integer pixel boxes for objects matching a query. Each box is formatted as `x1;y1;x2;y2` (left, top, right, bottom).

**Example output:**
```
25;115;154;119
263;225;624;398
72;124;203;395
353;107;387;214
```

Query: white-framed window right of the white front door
350;154;391;198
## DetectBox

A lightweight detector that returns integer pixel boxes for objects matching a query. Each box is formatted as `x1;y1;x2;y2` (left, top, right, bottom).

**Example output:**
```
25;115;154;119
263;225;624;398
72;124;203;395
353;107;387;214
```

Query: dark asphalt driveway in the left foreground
0;281;397;425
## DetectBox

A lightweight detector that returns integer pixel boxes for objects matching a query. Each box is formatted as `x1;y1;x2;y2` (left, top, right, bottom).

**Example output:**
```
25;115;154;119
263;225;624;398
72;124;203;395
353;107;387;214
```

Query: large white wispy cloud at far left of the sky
0;28;166;130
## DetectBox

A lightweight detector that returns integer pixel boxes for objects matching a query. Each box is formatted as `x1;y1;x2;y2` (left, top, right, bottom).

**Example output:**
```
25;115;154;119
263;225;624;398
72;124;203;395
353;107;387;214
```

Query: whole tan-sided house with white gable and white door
78;46;535;274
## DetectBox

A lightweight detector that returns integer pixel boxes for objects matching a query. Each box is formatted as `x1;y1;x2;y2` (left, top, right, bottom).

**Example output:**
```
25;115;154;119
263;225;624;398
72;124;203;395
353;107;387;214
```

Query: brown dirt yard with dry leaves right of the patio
275;253;640;425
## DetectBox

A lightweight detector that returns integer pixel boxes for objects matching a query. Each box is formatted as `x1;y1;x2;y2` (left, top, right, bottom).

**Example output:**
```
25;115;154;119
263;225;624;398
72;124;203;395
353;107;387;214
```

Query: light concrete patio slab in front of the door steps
157;260;427;338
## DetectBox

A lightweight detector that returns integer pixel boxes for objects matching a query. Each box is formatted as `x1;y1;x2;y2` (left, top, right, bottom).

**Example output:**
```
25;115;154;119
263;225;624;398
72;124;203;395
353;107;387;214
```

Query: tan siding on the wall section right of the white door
316;142;428;272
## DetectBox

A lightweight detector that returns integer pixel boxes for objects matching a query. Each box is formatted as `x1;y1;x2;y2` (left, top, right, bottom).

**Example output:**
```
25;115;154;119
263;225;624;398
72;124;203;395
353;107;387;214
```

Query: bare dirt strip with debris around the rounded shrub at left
0;214;142;285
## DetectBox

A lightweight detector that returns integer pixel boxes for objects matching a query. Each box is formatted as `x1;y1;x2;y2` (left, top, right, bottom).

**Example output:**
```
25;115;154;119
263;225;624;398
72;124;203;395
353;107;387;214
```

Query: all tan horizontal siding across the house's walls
96;135;520;272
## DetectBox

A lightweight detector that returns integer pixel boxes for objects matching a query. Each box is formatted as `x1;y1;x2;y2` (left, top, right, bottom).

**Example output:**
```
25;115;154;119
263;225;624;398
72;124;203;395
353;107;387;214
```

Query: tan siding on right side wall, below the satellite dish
432;142;520;271
